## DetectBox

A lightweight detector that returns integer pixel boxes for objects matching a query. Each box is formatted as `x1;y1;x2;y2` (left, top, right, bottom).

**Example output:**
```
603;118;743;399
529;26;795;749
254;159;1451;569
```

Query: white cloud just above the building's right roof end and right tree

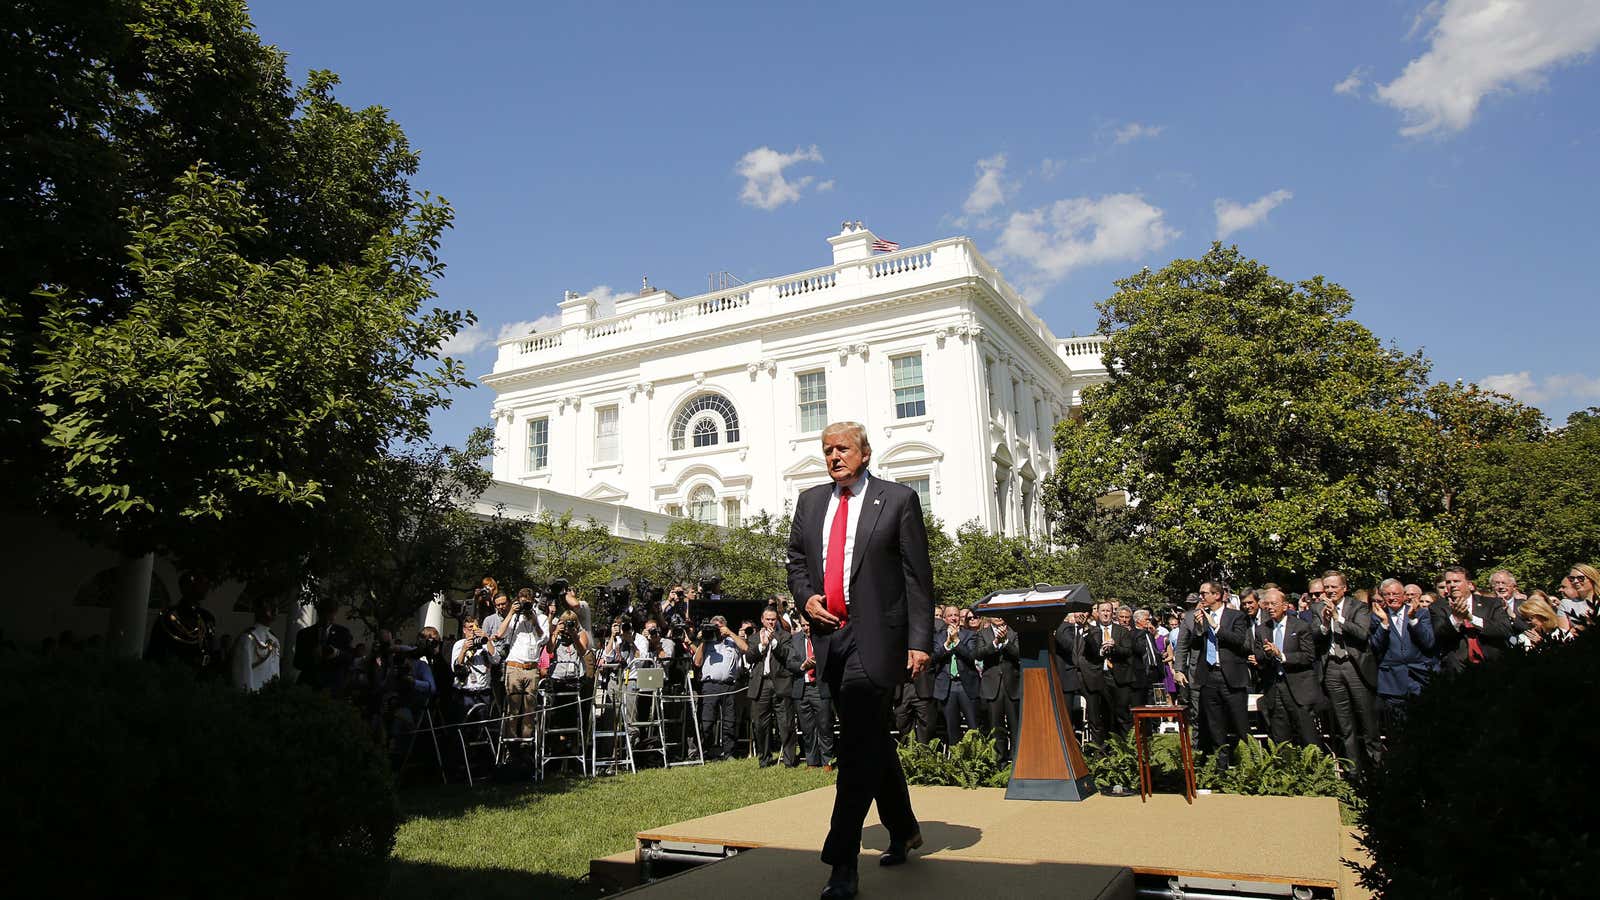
995;194;1179;287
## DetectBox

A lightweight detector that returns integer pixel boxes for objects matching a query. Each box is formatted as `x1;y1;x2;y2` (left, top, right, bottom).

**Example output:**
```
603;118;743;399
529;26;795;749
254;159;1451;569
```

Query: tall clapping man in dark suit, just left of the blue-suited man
1317;572;1382;772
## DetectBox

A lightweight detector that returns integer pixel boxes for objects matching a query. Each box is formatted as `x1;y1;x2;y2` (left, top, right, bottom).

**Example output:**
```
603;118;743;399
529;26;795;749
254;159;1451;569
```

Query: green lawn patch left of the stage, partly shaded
386;759;834;900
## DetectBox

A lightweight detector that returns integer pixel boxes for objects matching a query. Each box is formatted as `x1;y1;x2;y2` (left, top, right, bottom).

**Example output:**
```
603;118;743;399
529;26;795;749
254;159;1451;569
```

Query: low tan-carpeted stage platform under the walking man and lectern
613;788;1355;900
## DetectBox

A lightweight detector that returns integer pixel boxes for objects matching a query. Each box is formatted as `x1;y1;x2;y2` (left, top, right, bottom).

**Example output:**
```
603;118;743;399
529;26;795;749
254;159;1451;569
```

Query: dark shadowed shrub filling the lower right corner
1357;626;1600;900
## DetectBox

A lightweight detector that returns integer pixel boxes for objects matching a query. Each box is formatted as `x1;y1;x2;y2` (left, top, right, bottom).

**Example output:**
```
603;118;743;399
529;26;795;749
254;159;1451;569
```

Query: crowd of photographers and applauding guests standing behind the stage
128;564;1600;775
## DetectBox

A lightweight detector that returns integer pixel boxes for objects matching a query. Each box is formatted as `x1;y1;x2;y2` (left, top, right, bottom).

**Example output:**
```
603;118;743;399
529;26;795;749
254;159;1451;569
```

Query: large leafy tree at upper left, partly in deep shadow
0;0;472;569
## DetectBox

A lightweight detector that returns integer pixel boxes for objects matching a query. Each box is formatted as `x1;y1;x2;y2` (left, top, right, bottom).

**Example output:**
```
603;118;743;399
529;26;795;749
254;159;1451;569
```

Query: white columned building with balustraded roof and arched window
483;223;1106;535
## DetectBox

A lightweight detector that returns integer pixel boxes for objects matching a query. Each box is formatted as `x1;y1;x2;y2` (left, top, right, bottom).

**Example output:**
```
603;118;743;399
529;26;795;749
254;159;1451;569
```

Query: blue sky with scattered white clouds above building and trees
253;0;1600;442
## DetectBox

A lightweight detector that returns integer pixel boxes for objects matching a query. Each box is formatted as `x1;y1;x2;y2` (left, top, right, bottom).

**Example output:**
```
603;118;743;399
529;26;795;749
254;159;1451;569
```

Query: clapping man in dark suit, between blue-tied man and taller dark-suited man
1254;588;1322;746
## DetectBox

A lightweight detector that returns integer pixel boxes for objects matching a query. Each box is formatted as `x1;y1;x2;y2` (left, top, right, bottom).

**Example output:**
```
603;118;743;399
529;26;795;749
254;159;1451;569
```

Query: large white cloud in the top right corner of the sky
1378;0;1600;136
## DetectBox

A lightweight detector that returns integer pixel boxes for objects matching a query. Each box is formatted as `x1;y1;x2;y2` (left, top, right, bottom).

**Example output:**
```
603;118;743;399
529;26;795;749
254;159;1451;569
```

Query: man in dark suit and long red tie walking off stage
789;423;933;898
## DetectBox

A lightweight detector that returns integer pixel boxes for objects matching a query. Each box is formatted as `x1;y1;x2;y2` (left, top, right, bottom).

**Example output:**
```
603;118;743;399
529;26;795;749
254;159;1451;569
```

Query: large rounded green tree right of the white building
1050;243;1450;591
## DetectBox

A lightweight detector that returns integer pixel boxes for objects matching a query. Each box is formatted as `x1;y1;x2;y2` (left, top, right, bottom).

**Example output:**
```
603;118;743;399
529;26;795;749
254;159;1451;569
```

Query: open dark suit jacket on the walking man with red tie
789;471;933;690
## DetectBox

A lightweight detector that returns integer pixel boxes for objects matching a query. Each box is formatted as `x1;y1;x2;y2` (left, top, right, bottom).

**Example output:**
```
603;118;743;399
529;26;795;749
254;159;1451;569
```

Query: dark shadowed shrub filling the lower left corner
0;655;400;898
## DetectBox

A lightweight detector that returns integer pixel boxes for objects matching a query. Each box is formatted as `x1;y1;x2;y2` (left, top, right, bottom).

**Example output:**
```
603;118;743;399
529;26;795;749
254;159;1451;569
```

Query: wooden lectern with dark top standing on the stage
973;585;1094;801
